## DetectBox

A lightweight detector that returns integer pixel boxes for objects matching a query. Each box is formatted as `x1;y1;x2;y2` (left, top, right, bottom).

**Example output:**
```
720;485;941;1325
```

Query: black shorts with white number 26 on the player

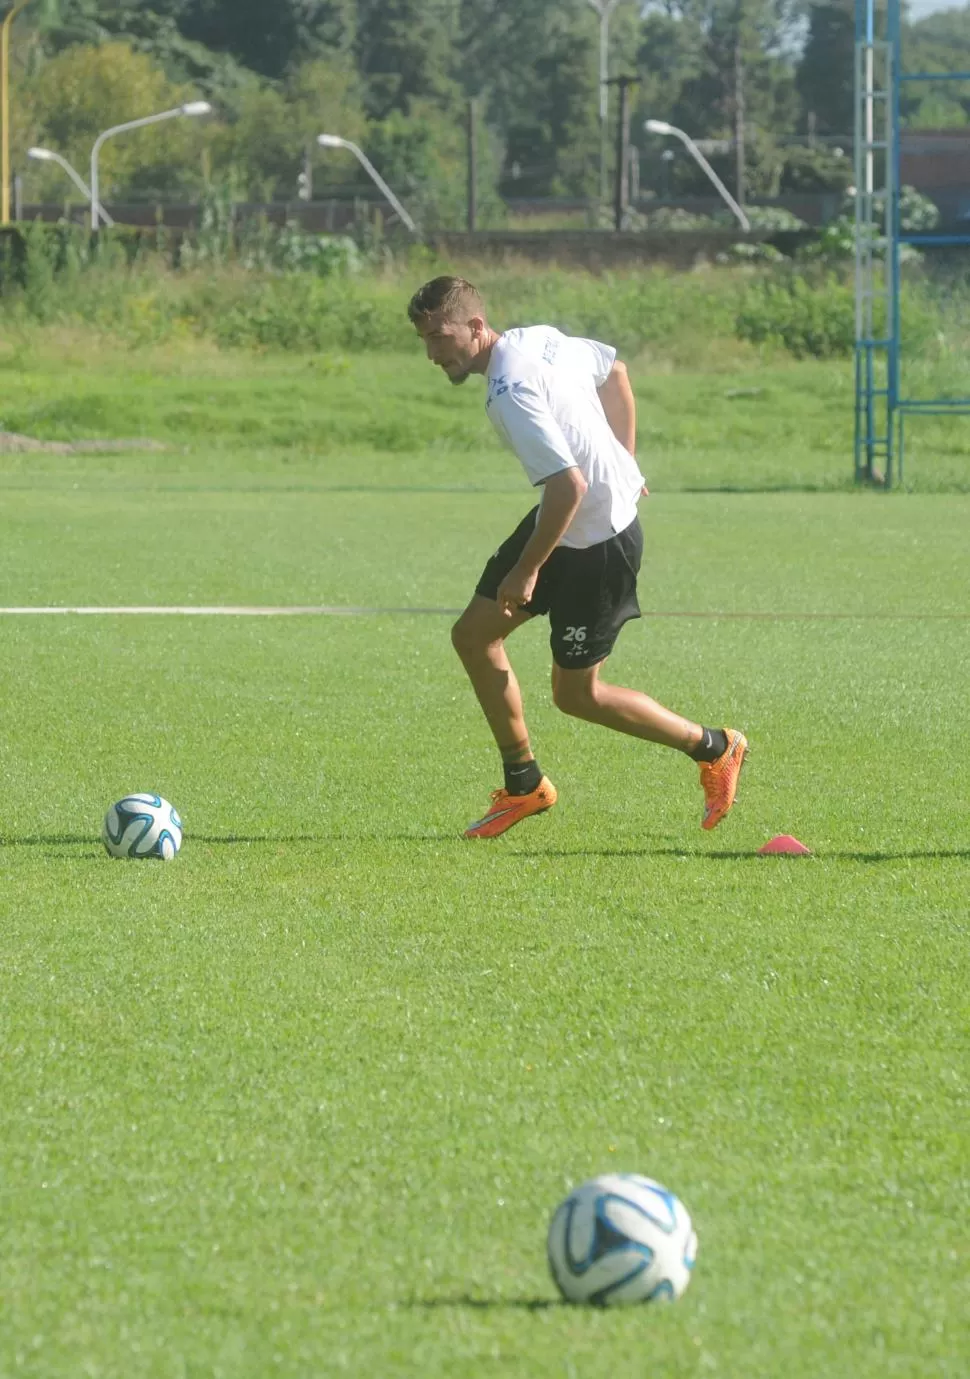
475;507;643;670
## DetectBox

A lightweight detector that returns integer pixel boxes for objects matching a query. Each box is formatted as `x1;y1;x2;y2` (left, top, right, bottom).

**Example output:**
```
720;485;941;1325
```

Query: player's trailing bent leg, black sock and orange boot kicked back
552;661;748;829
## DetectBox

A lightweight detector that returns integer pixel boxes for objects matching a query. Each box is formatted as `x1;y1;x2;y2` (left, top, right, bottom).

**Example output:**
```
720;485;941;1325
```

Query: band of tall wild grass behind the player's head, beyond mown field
0;235;970;368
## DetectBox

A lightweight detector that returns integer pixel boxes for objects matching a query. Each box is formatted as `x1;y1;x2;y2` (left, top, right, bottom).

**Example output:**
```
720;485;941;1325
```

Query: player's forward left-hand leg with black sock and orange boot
451;594;556;837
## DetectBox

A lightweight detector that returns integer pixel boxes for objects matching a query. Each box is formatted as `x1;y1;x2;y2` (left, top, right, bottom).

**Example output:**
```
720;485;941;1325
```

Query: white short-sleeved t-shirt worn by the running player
486;325;643;550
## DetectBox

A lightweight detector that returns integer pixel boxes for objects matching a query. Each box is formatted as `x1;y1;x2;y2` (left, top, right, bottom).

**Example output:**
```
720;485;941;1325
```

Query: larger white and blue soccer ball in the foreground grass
548;1174;697;1306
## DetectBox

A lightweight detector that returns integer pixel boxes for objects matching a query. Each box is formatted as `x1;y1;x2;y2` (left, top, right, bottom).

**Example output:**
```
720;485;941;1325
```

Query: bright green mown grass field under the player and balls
0;339;970;1379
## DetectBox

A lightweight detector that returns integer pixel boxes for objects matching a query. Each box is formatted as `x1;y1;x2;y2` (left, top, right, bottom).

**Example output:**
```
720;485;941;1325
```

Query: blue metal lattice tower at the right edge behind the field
855;0;970;485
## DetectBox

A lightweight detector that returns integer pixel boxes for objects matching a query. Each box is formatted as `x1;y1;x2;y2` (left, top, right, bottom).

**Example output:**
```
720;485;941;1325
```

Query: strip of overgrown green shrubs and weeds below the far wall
0;214;970;361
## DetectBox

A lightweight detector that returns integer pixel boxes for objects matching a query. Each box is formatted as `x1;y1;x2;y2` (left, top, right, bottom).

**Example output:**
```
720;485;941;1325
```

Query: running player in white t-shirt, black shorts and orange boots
407;277;748;838
